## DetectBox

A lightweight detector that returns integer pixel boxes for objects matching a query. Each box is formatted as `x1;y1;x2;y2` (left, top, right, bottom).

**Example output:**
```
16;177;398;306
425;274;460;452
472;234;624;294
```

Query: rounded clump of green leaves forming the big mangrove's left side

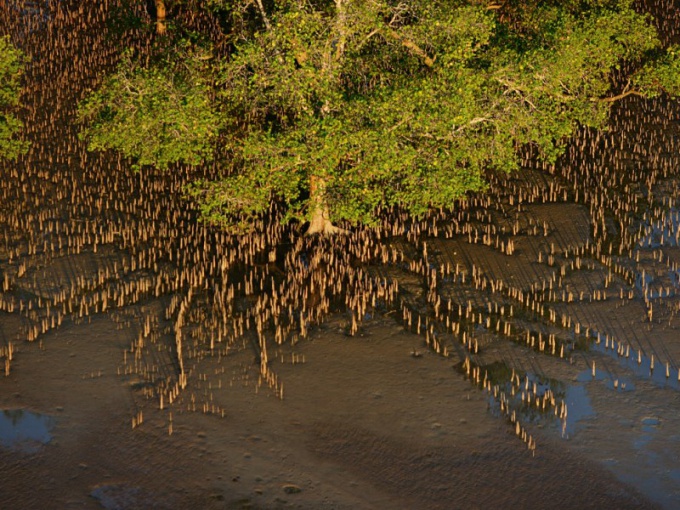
78;46;219;169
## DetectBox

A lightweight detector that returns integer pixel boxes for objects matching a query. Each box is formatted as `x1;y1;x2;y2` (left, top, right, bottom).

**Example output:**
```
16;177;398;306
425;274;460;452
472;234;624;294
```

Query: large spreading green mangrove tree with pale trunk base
80;0;680;232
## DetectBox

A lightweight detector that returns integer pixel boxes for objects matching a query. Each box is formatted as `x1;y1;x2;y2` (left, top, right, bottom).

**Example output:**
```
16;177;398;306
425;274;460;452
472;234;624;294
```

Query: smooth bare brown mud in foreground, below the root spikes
0;317;653;509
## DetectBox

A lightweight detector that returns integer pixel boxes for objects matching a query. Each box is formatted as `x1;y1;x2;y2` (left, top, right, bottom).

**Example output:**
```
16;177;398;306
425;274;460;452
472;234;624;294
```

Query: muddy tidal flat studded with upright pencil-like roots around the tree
0;2;680;508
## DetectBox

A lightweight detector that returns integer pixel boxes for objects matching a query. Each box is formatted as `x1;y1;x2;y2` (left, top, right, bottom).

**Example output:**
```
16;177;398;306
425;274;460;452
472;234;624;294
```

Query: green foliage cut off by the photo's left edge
0;37;28;159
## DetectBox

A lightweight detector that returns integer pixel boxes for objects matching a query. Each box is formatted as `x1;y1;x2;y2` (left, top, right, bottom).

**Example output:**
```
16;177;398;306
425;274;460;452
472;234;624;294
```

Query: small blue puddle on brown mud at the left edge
0;409;54;453
